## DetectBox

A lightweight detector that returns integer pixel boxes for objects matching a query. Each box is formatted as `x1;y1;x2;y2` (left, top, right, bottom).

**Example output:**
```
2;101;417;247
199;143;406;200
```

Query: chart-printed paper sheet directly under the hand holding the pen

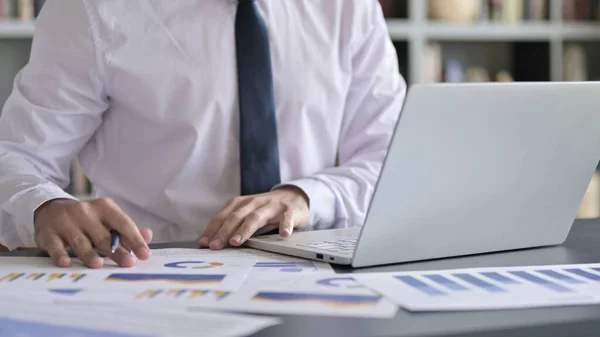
0;256;255;294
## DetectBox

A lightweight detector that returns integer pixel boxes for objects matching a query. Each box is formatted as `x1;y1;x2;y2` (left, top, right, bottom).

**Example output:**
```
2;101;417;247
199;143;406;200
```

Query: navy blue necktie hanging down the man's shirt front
235;0;281;195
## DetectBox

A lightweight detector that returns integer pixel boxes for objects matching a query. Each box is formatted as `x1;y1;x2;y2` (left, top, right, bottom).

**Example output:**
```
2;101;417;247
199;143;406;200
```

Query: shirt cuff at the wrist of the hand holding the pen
11;183;76;248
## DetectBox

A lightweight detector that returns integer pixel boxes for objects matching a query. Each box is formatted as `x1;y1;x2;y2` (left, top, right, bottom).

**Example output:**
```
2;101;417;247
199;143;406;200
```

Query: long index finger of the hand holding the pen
96;201;150;260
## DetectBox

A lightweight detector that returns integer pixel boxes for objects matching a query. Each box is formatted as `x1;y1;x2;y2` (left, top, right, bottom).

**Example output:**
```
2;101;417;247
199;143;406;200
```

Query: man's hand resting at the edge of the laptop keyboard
198;186;309;249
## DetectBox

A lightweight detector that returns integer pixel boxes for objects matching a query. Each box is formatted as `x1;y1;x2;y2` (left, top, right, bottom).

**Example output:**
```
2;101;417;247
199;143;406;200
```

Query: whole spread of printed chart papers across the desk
0;245;600;337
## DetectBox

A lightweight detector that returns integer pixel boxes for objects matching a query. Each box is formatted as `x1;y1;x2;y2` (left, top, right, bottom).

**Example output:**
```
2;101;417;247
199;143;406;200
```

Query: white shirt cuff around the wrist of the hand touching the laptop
274;178;336;230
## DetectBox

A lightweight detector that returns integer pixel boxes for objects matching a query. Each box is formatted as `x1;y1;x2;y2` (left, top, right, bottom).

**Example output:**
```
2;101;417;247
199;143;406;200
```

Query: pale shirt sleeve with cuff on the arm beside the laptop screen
286;1;406;229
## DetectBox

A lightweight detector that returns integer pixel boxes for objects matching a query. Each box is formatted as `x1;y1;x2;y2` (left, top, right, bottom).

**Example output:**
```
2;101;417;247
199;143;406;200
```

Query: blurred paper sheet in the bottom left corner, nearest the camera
0;297;280;337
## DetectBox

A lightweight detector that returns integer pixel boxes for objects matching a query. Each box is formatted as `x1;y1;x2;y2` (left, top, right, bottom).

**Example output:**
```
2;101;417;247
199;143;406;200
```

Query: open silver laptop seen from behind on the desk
247;82;600;267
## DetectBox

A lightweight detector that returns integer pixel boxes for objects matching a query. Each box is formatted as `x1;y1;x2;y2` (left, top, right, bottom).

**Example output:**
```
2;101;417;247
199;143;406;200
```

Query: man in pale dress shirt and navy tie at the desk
0;0;406;268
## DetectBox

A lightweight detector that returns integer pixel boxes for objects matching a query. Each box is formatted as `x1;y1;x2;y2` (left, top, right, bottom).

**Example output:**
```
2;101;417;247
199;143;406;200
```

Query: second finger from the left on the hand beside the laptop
210;199;264;249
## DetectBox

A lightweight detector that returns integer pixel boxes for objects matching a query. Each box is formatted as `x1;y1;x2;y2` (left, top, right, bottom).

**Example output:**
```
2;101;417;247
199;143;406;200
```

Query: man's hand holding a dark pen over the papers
34;199;152;268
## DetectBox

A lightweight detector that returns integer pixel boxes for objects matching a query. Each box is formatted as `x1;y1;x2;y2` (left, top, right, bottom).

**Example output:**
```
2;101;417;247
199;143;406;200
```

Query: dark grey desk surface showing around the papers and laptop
0;219;600;337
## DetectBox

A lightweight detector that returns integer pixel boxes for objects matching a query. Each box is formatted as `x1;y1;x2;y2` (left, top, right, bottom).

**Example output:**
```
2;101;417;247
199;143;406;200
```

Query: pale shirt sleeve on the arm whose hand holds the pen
0;0;107;249
